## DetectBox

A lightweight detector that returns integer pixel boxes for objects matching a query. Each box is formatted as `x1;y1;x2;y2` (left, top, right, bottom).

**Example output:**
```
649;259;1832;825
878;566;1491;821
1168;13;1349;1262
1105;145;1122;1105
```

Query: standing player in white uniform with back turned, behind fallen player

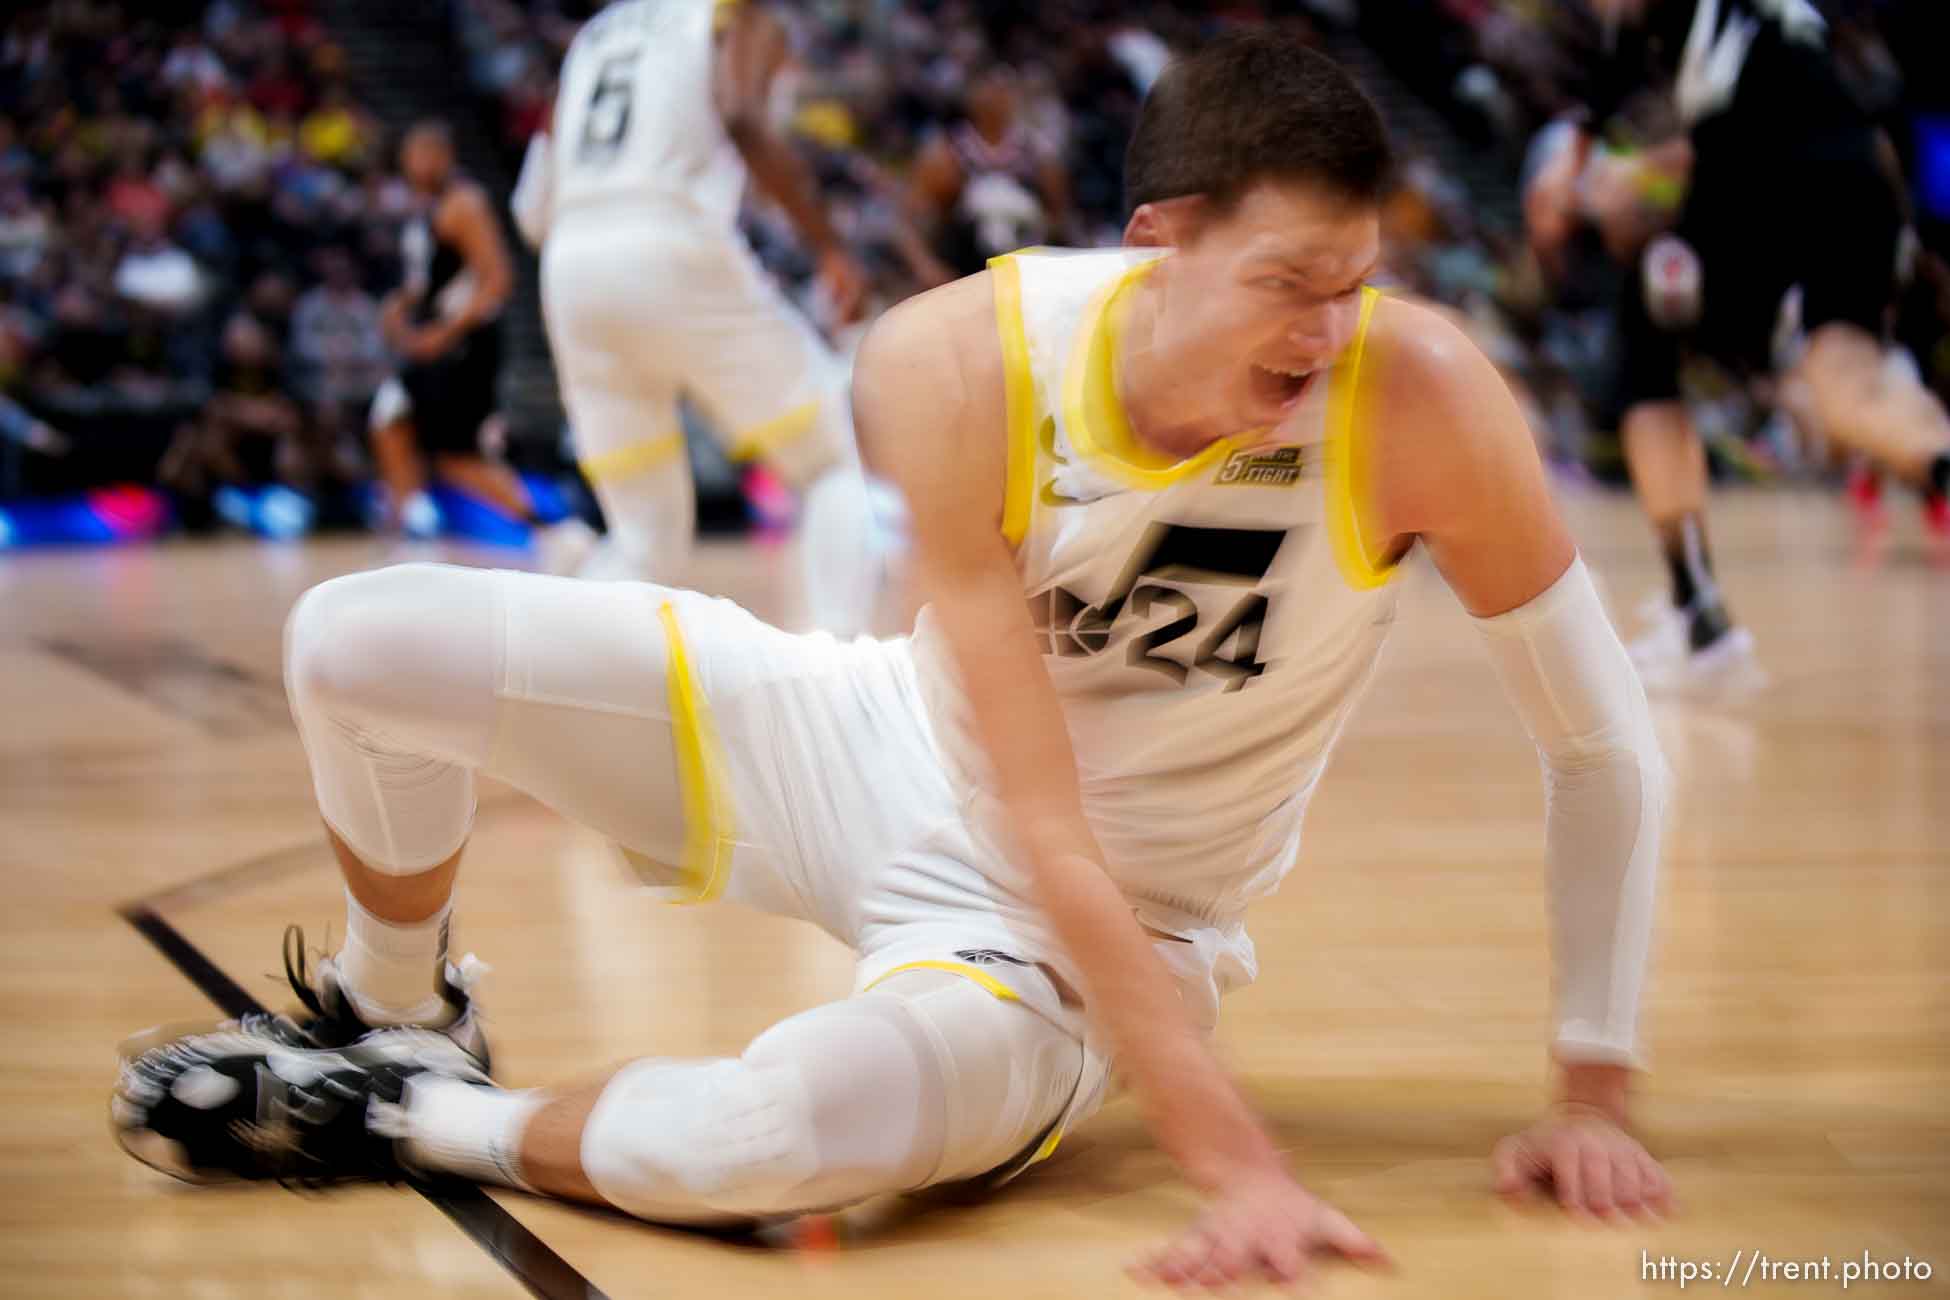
515;0;879;631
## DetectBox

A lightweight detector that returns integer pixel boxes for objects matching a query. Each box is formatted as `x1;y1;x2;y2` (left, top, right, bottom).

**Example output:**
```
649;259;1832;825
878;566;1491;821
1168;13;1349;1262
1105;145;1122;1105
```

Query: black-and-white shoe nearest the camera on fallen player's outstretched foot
109;1029;488;1187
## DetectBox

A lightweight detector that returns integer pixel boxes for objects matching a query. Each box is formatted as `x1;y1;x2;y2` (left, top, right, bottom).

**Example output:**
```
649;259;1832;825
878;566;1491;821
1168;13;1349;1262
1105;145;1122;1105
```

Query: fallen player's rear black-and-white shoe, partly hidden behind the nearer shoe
121;926;491;1074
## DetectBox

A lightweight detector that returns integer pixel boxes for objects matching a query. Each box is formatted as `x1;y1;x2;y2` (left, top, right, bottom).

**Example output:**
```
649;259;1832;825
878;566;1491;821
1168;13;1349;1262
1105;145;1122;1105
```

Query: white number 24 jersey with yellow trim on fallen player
915;249;1394;930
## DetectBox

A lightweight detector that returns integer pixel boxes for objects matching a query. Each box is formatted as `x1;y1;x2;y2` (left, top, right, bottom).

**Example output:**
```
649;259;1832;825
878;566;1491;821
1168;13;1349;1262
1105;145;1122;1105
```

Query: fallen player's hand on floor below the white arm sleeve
1490;1107;1673;1218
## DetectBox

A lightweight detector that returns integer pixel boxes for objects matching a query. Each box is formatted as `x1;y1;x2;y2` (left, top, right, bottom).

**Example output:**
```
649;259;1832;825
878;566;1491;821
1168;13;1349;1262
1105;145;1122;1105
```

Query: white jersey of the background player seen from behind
552;0;745;230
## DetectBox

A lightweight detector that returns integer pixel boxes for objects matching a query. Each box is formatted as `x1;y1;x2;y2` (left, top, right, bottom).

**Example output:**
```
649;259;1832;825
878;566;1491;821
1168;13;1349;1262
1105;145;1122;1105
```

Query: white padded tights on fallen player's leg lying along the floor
581;971;1080;1224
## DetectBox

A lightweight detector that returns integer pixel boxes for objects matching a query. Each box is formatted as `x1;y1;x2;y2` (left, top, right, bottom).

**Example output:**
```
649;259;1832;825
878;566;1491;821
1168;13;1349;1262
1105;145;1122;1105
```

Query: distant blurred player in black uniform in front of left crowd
372;121;583;554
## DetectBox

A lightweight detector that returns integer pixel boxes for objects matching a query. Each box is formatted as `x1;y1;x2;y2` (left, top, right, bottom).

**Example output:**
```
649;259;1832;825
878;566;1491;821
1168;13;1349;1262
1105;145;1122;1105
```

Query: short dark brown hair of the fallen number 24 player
1123;27;1392;210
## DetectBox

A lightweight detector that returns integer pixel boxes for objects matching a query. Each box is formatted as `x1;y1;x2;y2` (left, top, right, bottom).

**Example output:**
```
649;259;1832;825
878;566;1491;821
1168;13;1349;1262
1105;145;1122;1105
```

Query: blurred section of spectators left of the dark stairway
0;0;408;509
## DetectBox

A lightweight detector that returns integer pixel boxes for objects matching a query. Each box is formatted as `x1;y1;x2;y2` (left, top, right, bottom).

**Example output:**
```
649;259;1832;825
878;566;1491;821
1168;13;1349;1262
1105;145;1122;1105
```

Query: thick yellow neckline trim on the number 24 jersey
1063;259;1234;491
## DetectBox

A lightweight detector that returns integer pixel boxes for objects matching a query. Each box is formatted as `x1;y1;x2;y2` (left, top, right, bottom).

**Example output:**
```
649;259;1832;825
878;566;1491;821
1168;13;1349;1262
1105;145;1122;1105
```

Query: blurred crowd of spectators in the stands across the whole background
11;0;1950;530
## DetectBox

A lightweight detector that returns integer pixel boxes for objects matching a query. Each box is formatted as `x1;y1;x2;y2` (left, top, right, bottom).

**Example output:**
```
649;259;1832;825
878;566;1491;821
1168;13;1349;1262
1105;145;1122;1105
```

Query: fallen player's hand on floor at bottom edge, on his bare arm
1131;1173;1390;1290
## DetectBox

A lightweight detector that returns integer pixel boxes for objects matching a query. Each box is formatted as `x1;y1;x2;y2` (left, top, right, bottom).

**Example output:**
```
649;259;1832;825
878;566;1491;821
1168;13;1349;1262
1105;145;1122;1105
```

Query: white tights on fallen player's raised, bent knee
285;565;683;875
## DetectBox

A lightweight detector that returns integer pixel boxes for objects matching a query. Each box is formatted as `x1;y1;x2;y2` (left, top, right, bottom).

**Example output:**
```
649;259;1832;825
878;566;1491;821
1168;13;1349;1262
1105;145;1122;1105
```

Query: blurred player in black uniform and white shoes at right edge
1525;0;1950;688
